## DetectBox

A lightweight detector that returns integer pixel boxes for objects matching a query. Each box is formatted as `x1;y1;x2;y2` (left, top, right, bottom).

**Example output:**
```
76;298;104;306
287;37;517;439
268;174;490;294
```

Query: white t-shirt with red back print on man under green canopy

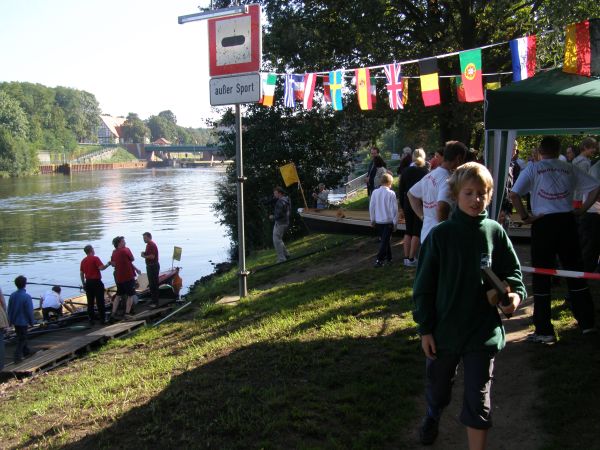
512;159;600;216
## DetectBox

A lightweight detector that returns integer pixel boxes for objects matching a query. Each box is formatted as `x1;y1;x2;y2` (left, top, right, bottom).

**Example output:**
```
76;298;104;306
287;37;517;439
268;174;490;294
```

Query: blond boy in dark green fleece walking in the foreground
413;163;526;450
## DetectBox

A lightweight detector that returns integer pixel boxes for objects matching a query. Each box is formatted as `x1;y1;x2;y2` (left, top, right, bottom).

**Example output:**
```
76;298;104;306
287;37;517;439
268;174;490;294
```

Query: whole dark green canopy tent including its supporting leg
484;69;600;218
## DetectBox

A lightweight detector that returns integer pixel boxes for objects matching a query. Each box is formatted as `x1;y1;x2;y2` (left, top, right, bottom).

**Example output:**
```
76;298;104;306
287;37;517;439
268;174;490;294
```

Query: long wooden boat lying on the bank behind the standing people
298;208;531;239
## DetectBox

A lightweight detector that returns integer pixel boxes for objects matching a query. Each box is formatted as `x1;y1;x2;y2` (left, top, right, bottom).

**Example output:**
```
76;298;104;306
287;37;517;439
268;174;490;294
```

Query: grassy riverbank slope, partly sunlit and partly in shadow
0;230;600;449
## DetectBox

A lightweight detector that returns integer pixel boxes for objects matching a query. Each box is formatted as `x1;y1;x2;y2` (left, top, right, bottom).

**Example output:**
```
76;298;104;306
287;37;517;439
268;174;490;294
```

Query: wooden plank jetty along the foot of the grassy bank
3;320;146;376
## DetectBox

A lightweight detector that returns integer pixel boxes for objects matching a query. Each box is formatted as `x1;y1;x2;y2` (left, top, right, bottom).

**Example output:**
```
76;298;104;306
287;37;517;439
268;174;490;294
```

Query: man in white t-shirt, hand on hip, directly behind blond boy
408;141;469;243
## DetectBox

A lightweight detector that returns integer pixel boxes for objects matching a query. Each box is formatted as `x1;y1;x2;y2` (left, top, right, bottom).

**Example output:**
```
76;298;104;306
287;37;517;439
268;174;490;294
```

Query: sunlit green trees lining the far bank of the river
0;82;215;176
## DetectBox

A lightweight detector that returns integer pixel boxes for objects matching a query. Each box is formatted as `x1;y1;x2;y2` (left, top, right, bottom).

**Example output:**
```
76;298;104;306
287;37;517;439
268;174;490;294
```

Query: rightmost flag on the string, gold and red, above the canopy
563;19;600;77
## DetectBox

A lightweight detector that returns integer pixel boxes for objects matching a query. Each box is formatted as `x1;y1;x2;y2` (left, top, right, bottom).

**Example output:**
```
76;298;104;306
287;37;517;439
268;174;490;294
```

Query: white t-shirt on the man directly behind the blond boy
408;167;452;242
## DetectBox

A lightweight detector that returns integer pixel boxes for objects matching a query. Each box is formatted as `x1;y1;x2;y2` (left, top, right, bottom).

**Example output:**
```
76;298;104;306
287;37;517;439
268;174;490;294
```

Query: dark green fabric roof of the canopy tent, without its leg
485;69;600;134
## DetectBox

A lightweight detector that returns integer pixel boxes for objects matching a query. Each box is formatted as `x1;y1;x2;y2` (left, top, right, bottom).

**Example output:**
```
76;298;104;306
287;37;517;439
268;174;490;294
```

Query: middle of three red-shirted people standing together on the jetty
110;236;141;318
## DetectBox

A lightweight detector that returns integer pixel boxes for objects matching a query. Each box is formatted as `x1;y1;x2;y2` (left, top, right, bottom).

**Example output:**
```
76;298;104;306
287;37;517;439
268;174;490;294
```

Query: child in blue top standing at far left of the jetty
8;275;35;363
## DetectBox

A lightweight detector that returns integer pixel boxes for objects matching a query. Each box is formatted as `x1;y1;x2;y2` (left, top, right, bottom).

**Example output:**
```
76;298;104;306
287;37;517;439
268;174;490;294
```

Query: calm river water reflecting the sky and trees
0;168;230;306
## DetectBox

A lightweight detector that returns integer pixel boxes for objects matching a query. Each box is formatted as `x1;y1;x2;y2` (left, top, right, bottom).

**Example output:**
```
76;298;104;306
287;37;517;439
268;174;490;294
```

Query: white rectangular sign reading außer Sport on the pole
210;73;260;106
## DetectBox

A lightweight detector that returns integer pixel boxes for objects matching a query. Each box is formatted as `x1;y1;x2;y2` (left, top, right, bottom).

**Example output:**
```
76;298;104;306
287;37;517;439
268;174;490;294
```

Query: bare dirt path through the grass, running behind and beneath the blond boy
246;238;545;450
